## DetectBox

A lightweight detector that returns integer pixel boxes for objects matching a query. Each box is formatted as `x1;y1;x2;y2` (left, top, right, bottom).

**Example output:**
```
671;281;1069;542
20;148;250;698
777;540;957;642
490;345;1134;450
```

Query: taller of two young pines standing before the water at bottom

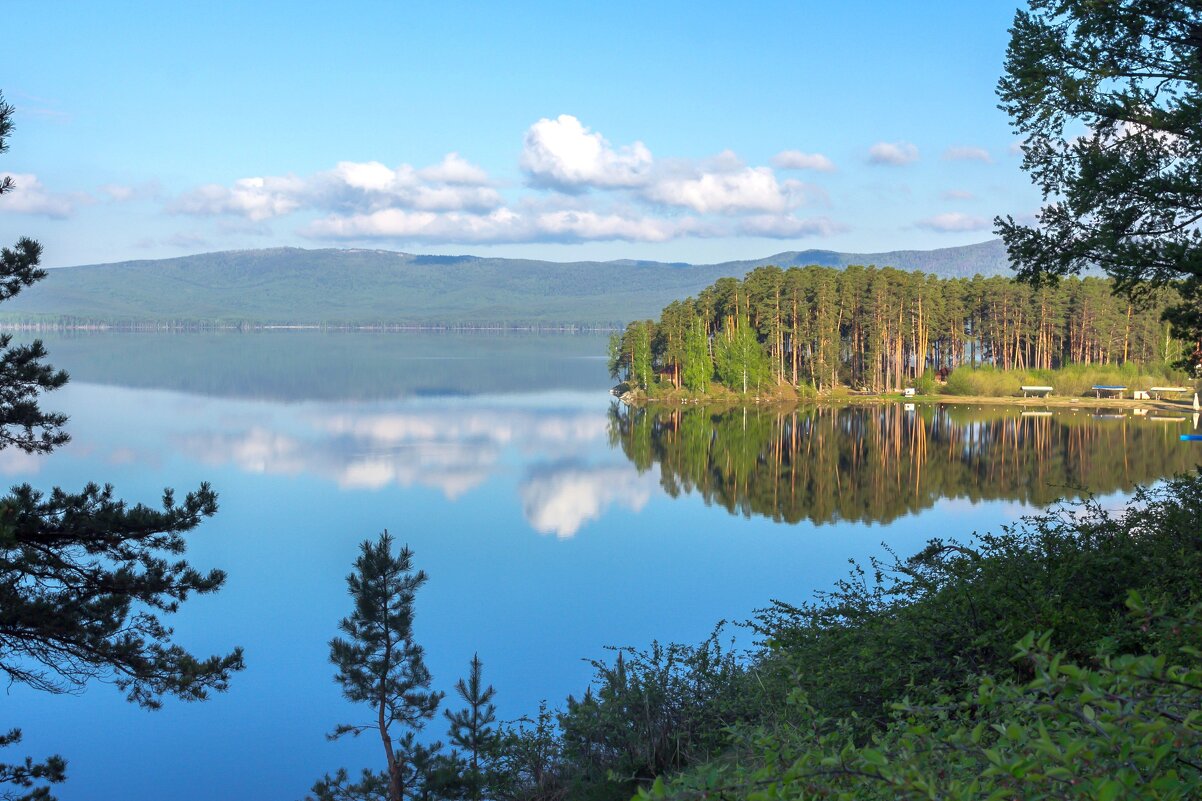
313;530;442;801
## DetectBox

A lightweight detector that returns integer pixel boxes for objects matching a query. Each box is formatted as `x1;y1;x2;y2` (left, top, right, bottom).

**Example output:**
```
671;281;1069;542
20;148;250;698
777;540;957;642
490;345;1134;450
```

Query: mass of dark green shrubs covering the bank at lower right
483;474;1202;801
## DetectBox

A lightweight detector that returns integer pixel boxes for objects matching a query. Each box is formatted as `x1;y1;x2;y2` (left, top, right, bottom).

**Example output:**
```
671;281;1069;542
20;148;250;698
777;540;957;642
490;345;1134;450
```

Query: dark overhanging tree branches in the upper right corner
996;0;1202;363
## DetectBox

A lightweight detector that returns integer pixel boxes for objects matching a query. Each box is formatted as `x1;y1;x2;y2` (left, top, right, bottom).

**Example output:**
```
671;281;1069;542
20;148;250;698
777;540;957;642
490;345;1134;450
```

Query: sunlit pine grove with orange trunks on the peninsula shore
609;266;1184;393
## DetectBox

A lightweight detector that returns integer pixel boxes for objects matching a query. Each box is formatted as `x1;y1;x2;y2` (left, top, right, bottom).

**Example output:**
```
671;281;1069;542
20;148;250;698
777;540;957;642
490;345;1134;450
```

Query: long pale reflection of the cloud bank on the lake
177;409;607;500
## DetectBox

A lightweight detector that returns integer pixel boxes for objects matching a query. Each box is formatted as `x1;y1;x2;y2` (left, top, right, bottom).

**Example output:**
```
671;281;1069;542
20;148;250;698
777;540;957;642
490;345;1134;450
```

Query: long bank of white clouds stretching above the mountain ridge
168;114;839;244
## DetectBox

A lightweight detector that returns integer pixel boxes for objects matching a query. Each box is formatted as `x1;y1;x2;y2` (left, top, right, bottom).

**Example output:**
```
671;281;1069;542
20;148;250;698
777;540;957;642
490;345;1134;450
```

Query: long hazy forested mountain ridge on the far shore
0;239;1010;326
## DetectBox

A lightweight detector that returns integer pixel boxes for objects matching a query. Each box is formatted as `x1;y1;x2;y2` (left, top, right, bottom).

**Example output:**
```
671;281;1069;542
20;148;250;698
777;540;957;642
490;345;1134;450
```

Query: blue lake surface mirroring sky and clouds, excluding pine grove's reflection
0;334;1173;801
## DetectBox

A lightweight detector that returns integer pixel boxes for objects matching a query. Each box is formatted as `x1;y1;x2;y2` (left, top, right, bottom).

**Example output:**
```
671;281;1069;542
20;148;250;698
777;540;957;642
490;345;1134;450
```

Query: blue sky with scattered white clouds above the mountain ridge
0;0;1040;266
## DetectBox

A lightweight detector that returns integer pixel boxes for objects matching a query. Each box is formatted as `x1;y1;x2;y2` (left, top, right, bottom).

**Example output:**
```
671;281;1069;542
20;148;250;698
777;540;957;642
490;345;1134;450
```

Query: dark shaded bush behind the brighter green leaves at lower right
756;471;1202;728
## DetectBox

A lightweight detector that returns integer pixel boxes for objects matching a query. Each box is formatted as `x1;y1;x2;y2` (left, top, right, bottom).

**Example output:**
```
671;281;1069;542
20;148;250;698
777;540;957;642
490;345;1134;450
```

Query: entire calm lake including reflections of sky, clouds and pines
0;331;1200;801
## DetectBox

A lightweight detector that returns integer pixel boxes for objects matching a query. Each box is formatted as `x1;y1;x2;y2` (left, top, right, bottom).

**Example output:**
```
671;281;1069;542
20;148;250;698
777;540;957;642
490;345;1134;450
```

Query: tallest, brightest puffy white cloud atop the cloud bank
522;114;651;191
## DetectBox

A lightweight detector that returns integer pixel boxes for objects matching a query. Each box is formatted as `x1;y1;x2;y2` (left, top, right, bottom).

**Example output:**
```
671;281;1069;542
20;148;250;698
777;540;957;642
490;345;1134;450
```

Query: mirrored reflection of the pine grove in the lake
609;404;1198;523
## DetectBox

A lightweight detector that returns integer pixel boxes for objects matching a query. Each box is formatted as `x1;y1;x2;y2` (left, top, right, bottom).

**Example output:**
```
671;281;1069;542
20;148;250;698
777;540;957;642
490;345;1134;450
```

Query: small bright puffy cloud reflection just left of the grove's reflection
520;463;657;539
